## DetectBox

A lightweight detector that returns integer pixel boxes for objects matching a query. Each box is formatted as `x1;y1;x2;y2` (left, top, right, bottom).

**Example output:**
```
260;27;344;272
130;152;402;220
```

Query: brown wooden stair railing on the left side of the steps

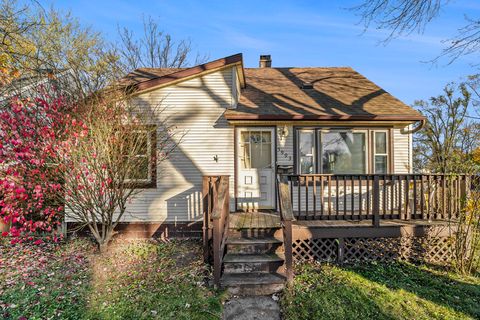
203;176;230;287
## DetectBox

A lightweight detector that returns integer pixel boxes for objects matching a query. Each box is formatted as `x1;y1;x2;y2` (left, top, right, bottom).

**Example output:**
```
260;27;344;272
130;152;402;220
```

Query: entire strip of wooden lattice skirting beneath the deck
293;236;453;264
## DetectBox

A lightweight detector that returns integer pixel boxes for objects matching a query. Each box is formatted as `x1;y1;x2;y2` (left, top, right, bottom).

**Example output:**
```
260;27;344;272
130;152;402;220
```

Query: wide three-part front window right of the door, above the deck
296;128;388;174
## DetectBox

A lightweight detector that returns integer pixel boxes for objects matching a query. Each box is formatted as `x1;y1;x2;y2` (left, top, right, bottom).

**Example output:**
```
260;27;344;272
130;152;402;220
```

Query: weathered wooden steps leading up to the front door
220;212;286;295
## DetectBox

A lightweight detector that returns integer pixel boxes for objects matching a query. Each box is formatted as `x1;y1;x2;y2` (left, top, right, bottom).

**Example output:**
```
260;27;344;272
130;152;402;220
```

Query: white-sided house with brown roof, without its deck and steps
112;54;424;235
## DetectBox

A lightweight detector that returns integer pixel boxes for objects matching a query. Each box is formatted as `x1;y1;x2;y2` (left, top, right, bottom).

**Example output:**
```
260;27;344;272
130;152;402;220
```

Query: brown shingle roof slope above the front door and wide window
225;67;423;121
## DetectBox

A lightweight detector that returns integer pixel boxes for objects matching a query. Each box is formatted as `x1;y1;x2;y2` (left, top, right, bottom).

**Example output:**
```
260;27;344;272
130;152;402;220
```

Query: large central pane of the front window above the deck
321;132;366;174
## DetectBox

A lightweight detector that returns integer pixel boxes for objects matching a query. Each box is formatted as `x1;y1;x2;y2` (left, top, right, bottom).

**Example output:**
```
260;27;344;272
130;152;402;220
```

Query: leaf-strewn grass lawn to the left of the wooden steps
0;240;224;320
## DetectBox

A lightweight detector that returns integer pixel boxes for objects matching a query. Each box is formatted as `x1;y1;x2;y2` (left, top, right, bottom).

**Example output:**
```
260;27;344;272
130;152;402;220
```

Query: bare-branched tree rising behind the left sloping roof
115;17;205;73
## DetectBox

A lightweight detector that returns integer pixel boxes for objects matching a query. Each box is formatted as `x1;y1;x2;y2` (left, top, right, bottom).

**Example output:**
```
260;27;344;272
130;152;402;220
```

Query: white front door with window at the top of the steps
236;127;275;210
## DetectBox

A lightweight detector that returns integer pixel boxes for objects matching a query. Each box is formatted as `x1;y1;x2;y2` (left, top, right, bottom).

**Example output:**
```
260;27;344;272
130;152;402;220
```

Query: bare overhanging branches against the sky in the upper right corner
352;0;480;63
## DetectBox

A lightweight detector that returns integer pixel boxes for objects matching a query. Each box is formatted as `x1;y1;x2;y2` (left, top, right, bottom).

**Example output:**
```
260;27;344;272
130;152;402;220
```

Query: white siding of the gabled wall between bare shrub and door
121;68;235;222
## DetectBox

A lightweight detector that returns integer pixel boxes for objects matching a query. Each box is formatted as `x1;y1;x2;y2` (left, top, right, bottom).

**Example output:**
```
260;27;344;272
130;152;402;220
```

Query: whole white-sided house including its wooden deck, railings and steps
106;54;469;294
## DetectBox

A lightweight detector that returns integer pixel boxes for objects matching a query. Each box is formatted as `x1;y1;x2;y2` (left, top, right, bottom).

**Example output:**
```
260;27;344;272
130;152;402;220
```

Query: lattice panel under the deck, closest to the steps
292;238;338;262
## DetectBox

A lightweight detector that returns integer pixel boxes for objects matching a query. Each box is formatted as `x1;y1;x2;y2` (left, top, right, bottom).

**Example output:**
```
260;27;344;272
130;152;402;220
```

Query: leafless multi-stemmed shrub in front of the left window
64;89;181;251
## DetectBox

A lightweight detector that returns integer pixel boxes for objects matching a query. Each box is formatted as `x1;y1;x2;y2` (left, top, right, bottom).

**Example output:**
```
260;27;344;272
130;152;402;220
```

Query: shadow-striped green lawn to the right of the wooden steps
281;263;480;320
